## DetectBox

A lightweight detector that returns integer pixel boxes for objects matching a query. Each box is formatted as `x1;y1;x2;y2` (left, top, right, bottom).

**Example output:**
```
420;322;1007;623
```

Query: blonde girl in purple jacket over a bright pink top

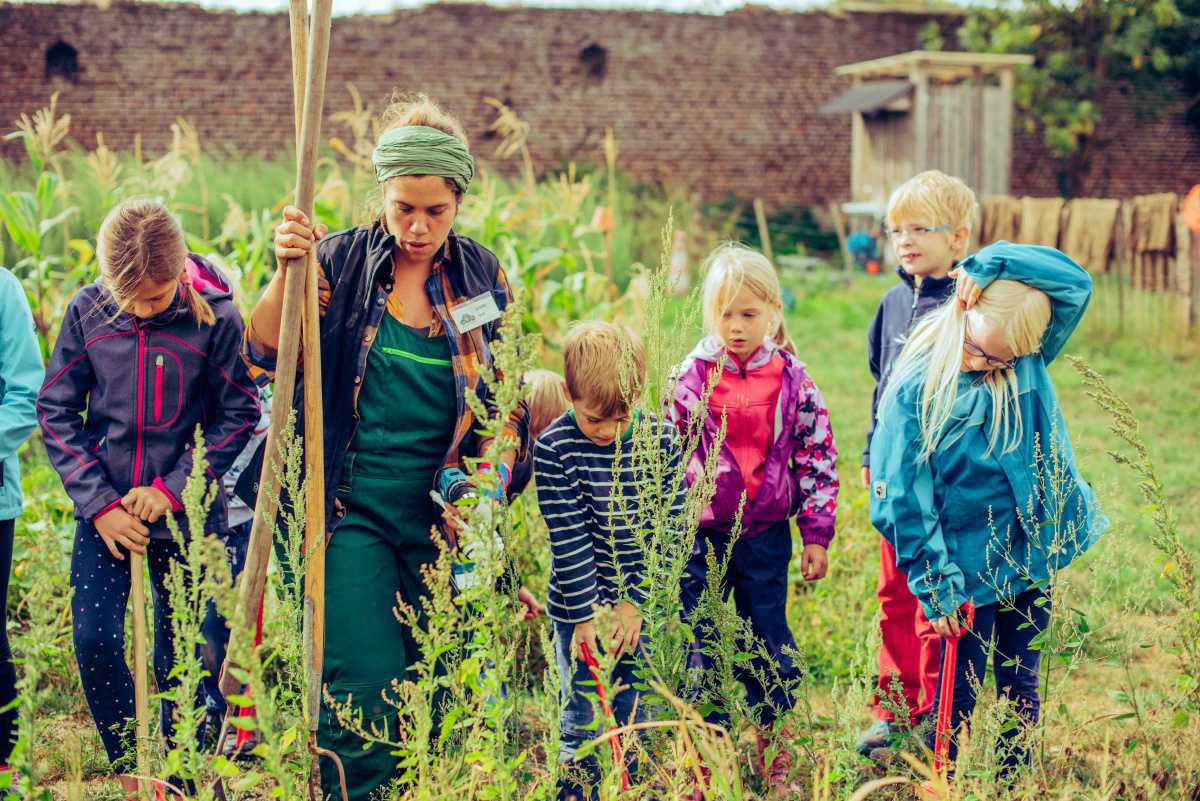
671;245;838;787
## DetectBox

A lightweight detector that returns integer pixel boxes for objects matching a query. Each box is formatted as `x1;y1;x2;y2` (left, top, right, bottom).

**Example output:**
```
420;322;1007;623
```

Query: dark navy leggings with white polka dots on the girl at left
71;522;180;771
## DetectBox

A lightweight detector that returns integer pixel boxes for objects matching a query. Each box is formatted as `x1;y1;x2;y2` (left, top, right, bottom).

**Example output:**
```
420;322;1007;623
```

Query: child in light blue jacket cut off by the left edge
0;267;44;771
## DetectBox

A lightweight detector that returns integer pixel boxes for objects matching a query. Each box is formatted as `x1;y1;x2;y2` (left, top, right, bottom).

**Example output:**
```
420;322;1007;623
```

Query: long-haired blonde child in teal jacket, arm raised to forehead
871;242;1106;765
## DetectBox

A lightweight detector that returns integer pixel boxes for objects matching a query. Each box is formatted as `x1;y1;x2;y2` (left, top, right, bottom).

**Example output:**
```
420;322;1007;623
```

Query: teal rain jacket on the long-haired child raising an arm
870;242;1108;619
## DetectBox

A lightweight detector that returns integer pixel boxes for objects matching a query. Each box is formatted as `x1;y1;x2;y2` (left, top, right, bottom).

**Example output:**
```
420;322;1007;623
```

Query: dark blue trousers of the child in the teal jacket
926;590;1050;769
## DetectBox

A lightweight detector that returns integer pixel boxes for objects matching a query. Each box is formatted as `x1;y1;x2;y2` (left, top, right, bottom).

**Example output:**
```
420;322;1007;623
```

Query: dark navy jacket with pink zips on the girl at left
37;255;259;540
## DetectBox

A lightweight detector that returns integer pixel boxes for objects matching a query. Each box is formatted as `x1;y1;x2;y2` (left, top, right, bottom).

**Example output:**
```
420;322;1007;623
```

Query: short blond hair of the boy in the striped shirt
563;320;646;417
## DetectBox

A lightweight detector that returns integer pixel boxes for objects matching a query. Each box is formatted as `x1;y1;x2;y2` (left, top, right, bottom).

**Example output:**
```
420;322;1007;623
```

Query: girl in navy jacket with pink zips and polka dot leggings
37;200;258;791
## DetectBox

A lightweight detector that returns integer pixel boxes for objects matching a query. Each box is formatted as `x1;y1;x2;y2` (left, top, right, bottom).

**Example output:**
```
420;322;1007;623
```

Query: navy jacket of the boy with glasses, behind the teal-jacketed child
863;267;954;468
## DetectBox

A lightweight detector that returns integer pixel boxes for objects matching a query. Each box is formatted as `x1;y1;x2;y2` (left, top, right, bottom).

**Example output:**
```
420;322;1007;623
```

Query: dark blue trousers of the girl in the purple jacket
680;520;802;727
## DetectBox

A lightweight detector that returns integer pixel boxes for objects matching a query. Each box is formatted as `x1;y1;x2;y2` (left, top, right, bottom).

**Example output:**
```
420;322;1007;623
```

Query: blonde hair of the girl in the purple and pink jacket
702;242;796;356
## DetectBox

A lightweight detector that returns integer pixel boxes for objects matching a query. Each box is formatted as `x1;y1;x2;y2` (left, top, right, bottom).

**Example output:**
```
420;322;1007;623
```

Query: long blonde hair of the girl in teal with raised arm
880;281;1050;462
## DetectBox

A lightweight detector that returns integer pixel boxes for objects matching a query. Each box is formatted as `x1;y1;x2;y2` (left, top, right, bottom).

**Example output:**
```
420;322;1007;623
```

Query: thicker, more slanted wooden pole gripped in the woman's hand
221;0;332;693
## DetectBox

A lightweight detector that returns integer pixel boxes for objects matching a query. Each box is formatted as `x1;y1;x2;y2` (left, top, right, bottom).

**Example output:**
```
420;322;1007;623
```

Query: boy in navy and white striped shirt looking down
534;320;686;801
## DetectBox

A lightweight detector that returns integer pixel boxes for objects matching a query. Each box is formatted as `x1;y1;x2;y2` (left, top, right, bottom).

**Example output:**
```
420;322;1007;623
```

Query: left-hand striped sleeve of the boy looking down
534;440;598;624
